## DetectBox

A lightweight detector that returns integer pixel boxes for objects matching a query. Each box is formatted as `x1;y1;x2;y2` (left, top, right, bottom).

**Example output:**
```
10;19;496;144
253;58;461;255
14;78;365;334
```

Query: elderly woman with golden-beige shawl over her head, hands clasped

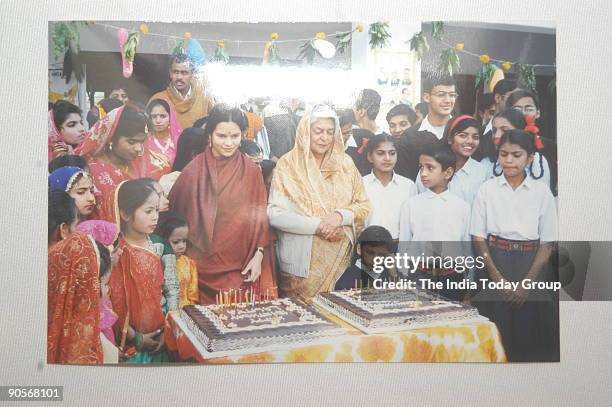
268;105;370;302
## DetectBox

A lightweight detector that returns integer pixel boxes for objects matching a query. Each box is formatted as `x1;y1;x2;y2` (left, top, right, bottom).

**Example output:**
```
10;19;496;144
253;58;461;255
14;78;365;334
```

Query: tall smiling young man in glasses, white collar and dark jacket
395;72;458;181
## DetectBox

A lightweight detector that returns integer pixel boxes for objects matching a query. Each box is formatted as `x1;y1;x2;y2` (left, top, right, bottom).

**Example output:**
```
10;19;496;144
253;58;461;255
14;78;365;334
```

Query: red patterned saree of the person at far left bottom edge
47;233;103;364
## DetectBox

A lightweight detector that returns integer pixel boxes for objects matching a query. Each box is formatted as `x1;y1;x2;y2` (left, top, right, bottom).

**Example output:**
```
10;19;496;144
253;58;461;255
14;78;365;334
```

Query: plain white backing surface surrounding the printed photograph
0;0;612;406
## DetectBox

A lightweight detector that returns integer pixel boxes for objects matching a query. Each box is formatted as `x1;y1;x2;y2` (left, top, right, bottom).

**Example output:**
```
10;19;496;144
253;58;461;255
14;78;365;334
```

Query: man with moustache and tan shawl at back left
149;54;214;129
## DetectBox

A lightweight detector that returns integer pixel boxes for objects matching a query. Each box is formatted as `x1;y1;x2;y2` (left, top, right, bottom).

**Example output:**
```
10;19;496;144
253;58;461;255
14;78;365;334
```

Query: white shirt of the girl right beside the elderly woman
363;172;416;239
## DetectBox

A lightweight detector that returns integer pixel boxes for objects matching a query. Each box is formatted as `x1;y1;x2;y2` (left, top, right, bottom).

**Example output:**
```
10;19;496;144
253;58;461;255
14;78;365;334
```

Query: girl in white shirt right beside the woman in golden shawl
363;134;416;240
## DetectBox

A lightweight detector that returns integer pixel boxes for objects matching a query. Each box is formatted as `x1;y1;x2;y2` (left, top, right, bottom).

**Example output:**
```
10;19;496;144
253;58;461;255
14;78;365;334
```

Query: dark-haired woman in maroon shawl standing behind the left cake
169;105;276;304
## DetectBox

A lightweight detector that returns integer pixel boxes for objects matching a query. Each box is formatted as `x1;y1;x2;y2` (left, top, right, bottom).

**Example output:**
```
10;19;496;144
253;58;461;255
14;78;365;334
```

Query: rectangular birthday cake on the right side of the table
314;289;483;333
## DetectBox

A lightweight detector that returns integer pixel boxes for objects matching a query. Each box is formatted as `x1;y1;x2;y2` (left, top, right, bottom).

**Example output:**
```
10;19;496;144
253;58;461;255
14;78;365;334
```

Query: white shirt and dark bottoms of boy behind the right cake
399;189;471;301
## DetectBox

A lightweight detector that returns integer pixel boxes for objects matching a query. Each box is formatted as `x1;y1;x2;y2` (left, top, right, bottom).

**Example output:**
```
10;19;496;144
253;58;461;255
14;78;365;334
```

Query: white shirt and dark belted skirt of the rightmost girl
470;175;559;361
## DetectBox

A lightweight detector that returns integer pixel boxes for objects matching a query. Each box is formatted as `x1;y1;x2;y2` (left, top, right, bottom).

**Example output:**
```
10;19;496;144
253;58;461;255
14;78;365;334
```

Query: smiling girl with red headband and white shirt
417;115;488;205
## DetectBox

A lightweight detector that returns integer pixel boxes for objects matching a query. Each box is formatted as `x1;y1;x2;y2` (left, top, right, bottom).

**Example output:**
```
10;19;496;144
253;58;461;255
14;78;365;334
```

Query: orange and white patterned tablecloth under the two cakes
165;313;506;363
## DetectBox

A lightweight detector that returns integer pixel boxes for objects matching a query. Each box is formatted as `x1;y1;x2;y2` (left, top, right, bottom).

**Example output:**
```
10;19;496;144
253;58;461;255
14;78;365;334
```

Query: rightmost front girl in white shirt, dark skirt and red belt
470;130;559;361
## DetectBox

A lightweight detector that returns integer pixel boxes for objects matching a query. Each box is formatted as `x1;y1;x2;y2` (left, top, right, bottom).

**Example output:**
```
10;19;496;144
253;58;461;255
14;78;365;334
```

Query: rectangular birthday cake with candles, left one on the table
181;292;345;353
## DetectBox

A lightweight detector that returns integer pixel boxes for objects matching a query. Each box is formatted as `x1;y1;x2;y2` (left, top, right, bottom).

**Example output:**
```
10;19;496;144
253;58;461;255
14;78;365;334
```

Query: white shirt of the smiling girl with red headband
416;157;489;205
